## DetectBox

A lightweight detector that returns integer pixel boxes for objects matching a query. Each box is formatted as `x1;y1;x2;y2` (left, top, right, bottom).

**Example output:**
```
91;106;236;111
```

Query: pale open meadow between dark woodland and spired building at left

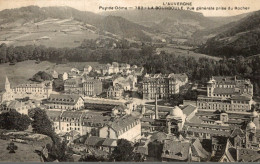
0;60;104;90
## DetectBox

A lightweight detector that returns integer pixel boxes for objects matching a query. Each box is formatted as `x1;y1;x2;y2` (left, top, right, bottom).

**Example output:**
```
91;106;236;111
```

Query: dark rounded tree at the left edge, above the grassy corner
0;110;31;131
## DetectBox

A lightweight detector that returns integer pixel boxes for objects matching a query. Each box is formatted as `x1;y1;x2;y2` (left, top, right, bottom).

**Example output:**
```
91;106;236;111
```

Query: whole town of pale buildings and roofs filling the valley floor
0;62;260;162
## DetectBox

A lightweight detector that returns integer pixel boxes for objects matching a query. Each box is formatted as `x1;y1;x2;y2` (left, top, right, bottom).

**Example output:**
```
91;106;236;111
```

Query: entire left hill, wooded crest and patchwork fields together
0;6;153;47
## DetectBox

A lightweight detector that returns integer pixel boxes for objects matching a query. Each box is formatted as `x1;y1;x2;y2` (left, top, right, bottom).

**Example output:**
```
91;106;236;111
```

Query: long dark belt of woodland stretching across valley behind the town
0;44;260;96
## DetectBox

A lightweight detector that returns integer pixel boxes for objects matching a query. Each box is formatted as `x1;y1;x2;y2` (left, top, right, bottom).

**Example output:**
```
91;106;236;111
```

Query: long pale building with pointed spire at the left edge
1;77;52;102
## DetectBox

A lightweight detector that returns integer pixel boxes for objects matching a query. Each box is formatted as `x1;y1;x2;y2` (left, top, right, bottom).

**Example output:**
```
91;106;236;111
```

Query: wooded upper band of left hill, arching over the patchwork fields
0;6;150;41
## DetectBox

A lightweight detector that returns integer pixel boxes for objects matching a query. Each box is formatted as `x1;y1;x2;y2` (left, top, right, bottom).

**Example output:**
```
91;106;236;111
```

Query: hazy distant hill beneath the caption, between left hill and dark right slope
101;10;251;39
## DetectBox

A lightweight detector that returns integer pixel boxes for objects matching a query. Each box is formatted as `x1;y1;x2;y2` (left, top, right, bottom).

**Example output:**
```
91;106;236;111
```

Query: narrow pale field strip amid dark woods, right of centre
157;47;221;61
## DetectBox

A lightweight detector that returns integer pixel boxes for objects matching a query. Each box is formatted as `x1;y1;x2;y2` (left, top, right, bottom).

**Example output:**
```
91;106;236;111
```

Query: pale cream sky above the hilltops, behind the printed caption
0;0;260;16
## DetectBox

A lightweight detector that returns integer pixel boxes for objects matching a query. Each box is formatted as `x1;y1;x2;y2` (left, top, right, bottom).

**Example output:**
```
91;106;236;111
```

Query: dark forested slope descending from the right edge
199;11;260;57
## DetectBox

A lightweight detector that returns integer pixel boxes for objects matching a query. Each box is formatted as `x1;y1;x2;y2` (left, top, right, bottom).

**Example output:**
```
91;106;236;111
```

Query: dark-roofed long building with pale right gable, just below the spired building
46;94;84;110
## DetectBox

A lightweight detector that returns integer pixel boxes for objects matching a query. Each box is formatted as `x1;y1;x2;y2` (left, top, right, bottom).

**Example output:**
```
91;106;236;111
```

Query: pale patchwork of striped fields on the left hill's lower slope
0;19;100;48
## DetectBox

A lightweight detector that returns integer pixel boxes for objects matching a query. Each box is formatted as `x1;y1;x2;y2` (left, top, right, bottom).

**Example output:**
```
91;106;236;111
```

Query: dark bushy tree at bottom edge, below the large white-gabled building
110;139;135;162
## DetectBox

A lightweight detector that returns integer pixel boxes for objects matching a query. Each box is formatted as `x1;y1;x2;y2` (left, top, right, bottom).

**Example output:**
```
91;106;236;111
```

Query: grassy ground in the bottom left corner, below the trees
0;140;41;162
